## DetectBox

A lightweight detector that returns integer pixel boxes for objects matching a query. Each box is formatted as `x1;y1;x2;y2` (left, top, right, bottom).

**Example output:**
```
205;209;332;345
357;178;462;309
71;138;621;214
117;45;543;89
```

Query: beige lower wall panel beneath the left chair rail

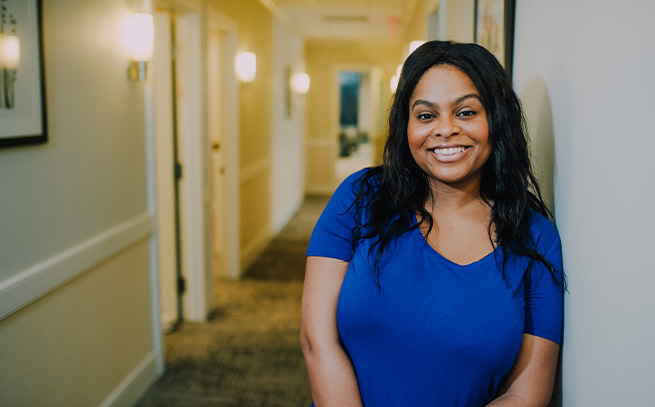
0;242;154;407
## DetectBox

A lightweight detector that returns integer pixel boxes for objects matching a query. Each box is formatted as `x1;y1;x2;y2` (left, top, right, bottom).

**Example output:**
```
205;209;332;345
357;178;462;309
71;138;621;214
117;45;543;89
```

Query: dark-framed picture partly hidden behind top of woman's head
473;0;515;77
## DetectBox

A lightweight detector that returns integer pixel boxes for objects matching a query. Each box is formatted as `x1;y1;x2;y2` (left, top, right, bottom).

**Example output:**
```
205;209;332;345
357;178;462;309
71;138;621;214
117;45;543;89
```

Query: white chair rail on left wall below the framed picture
0;213;152;320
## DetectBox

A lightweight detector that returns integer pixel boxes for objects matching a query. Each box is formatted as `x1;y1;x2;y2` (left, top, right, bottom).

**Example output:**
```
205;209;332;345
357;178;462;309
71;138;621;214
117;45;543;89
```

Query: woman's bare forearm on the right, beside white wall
487;334;559;407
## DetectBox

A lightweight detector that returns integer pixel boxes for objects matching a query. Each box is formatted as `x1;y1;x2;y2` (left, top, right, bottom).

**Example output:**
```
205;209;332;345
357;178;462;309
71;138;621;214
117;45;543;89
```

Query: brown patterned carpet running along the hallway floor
137;198;327;407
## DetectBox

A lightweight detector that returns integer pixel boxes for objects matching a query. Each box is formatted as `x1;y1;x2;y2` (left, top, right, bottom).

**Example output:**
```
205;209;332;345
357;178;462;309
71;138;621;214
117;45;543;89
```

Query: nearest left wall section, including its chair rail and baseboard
0;0;156;406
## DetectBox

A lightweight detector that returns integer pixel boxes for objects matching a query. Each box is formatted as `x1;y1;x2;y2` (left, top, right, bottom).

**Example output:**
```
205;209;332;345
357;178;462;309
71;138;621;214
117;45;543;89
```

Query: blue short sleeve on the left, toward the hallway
307;169;367;261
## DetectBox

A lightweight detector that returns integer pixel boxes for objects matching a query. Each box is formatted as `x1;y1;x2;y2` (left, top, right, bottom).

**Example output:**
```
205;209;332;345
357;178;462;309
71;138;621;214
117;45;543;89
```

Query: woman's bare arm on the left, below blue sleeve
300;256;363;407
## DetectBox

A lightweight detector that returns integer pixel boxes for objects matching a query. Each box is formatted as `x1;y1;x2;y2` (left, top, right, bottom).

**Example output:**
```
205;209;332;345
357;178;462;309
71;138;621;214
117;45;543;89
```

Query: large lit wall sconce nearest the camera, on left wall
124;13;155;82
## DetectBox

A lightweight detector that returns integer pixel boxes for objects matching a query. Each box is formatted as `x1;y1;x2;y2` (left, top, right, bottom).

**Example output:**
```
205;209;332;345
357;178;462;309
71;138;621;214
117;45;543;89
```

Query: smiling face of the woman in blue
407;65;491;193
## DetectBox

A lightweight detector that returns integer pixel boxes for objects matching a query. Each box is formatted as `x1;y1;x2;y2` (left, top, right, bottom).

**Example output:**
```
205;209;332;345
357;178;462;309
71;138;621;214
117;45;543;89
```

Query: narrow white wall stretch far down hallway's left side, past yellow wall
271;19;311;234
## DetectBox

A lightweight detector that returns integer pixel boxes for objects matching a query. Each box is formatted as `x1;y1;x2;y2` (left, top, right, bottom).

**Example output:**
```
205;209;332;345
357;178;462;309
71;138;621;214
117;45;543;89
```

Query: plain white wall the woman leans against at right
514;0;655;407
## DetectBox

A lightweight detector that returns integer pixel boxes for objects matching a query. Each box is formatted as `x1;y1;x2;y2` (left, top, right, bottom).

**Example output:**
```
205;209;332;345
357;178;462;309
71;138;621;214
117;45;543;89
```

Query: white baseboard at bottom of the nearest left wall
100;351;157;407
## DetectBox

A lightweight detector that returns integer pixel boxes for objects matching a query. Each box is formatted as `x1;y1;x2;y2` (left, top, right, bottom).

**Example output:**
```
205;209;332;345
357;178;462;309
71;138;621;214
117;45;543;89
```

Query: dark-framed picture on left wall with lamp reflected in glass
0;0;48;147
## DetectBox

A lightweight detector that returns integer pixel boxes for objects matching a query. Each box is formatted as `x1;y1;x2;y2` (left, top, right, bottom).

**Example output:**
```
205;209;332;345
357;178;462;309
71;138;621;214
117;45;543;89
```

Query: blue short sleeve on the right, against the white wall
524;218;564;345
